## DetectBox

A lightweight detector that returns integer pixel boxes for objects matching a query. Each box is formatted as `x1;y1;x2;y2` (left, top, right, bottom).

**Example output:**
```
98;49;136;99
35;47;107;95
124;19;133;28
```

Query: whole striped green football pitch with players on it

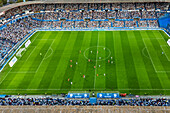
0;30;170;95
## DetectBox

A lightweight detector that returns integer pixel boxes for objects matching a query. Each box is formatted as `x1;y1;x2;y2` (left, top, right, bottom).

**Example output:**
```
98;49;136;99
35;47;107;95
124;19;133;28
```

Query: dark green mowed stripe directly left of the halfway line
83;31;98;90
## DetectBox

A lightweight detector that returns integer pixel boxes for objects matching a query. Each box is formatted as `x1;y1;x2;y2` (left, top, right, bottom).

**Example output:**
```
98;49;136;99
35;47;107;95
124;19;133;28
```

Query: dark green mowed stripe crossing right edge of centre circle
105;31;117;90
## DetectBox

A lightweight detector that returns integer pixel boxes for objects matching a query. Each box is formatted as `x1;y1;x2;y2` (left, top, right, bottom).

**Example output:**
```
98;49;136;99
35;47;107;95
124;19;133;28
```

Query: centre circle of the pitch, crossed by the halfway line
84;46;111;61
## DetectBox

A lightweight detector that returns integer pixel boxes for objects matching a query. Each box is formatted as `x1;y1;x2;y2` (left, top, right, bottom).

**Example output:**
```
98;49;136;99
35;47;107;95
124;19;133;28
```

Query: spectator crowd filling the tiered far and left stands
0;3;170;61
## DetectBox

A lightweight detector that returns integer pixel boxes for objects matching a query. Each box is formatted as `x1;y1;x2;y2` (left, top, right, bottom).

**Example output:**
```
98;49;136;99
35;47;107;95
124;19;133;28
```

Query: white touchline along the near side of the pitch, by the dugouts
0;89;170;91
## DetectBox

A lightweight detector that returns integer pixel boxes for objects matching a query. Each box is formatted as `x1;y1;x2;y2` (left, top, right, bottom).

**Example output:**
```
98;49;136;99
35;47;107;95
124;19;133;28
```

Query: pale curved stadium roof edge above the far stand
0;0;170;13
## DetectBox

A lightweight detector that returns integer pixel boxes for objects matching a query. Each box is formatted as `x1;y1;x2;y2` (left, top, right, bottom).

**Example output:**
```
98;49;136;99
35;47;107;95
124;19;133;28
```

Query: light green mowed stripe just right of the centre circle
113;31;129;93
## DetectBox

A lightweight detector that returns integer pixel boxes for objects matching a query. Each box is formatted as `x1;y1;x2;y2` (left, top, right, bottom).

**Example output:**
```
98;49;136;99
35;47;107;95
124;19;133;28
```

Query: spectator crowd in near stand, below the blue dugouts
0;97;170;106
